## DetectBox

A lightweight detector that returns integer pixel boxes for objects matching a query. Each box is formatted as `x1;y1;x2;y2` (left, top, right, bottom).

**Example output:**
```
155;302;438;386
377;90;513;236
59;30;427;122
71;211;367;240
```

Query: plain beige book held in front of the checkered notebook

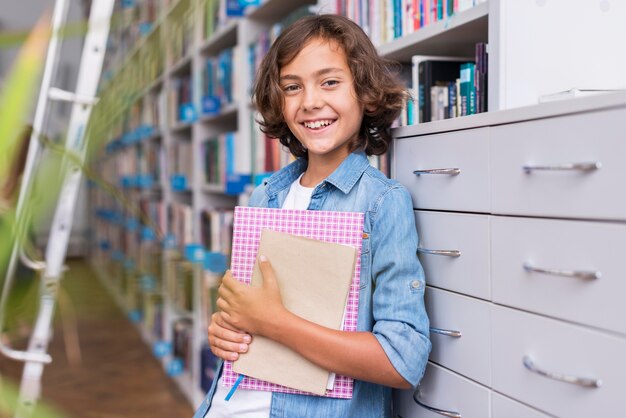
233;229;357;395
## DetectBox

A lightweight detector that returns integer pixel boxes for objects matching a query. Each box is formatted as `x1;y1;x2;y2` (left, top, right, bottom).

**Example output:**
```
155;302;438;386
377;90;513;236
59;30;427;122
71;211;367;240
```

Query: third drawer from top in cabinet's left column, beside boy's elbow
425;286;491;386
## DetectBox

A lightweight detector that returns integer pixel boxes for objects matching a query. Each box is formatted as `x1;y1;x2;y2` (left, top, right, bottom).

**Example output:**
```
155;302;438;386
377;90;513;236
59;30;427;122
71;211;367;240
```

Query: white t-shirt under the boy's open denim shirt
204;173;315;418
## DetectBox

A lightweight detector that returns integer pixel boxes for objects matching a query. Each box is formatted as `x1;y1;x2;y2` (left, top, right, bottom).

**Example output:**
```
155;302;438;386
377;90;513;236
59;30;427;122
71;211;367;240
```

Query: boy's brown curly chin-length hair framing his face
252;14;408;158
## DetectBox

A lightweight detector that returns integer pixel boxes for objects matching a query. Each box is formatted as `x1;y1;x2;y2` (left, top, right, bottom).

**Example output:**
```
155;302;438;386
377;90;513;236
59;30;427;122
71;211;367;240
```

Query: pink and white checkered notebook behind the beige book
222;206;364;399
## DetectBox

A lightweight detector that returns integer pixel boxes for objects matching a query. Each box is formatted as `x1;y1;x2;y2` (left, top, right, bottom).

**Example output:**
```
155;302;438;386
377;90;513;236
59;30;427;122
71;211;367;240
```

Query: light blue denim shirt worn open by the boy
194;151;431;418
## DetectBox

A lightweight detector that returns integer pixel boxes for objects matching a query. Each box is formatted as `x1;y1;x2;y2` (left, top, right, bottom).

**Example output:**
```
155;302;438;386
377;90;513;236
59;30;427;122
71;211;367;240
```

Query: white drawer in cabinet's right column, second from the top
491;216;626;334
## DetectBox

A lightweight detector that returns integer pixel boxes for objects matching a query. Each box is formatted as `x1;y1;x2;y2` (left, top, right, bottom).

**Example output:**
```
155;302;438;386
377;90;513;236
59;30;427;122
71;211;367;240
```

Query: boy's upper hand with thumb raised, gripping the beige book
217;256;285;335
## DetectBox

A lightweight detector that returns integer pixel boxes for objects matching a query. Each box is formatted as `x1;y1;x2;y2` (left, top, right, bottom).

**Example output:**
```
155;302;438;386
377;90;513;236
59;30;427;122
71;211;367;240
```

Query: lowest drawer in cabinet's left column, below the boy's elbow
394;363;491;418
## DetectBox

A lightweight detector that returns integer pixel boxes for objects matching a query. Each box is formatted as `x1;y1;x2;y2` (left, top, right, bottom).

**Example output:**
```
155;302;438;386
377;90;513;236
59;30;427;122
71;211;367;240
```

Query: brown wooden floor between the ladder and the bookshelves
0;260;193;418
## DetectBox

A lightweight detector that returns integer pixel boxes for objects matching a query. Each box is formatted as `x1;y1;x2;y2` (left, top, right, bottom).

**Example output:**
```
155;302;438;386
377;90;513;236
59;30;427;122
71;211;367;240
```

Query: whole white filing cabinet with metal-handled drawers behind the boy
394;92;626;418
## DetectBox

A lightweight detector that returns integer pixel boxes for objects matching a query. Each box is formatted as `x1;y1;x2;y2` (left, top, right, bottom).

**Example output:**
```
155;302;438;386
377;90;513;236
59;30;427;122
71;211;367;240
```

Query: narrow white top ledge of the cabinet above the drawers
393;91;626;139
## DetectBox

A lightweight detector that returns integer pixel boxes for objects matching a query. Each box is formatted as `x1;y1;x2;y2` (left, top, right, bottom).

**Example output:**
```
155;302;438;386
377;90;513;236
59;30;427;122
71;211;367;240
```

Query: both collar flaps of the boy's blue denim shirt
265;150;369;197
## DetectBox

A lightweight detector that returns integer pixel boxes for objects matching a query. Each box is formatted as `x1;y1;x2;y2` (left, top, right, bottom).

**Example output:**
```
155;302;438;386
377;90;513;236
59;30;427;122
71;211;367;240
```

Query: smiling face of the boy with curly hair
280;39;363;163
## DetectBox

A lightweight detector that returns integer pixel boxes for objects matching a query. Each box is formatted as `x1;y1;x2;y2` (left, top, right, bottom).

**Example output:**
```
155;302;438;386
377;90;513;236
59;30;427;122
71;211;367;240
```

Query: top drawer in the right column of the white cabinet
491;109;626;220
